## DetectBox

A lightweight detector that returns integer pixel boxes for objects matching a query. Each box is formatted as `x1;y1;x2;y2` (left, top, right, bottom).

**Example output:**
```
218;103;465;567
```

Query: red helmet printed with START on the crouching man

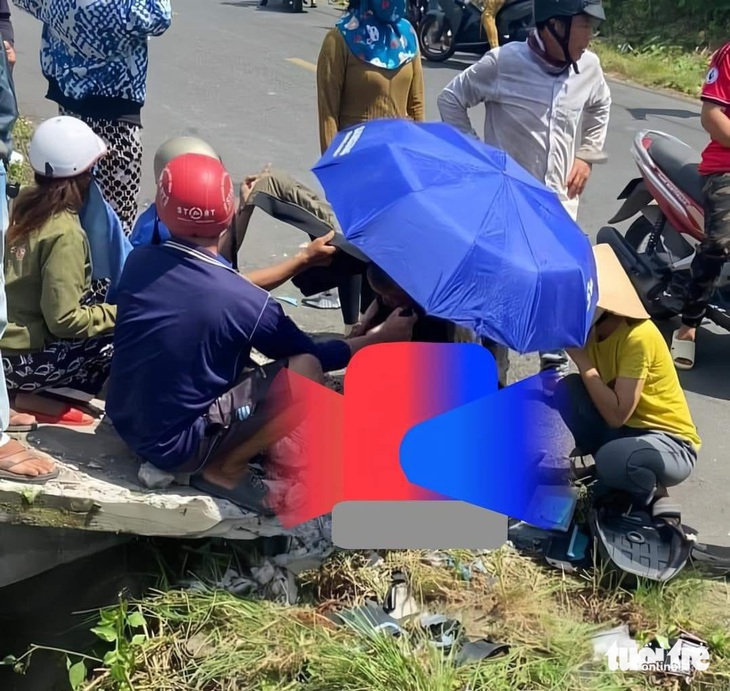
155;154;234;238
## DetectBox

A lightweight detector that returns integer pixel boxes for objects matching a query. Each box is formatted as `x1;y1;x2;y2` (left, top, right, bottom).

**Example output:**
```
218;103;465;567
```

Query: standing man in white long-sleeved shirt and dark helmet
438;0;611;379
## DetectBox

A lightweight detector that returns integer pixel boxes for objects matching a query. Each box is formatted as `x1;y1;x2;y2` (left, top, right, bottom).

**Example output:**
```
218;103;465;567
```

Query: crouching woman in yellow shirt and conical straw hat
556;245;701;520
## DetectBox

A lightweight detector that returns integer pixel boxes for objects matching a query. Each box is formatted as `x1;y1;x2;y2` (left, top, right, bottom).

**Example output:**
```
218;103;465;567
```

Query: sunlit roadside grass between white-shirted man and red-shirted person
592;39;711;97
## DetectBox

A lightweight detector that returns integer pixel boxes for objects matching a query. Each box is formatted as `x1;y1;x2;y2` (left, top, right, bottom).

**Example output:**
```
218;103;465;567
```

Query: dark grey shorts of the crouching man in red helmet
175;358;289;473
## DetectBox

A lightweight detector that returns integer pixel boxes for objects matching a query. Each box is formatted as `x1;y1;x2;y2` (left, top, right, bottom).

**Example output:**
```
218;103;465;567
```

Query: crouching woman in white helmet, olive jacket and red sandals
0;117;116;424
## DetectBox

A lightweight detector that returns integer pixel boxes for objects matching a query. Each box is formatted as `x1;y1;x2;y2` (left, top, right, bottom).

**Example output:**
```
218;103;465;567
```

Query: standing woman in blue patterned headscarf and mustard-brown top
317;0;425;331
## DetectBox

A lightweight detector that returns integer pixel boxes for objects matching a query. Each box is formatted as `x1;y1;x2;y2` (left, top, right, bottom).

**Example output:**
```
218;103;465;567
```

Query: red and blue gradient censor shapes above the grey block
264;343;564;528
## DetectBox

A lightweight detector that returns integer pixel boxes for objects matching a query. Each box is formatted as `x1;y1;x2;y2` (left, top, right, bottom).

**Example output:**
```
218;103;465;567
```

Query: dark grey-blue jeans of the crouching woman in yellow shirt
555;374;697;504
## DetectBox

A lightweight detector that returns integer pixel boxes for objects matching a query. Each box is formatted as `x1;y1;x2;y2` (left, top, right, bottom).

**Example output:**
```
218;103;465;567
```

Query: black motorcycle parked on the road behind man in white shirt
412;0;534;62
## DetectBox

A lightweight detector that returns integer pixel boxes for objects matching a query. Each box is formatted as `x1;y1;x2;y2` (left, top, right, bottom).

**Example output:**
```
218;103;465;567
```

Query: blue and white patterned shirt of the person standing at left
13;0;172;106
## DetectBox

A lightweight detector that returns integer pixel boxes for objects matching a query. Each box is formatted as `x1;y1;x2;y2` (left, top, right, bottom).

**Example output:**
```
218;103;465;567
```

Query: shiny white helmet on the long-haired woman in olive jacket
28;115;107;178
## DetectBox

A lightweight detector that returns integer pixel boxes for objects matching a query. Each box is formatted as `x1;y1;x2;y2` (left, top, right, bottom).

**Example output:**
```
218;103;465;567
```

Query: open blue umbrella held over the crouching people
313;119;597;353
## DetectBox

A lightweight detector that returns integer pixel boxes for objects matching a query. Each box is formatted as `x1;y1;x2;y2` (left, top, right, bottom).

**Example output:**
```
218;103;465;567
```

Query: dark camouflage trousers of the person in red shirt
682;173;730;328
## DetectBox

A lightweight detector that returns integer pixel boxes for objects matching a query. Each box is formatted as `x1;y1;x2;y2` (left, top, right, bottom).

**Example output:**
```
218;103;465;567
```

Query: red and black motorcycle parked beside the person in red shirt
597;130;730;331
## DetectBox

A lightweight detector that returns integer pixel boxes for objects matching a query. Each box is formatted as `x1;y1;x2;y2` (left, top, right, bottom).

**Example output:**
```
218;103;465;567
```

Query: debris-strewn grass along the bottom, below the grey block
11;546;730;691
